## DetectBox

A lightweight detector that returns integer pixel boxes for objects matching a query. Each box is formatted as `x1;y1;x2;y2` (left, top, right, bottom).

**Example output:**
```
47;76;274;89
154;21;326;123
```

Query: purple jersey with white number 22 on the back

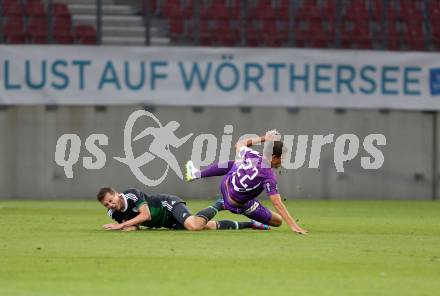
223;147;278;203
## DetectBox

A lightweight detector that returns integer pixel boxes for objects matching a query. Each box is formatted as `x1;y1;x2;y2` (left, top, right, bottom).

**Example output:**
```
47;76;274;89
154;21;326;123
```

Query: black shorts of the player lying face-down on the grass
159;194;192;230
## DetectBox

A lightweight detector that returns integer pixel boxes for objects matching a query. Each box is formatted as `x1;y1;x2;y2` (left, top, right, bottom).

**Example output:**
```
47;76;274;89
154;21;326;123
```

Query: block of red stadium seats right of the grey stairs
159;0;434;50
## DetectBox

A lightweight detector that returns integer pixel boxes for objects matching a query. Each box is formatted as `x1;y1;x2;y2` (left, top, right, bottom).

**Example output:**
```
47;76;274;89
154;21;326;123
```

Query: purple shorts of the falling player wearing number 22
220;180;272;225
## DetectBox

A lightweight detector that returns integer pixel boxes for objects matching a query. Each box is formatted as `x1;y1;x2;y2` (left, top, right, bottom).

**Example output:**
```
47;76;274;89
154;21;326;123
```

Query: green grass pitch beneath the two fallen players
0;201;440;296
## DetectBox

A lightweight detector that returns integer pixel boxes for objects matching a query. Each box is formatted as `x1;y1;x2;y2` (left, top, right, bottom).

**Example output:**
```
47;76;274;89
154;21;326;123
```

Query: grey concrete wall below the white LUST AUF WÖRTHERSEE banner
0;106;434;200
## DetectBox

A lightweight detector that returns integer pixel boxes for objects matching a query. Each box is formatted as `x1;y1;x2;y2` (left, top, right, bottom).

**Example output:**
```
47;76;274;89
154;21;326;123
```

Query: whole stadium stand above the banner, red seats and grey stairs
1;0;440;51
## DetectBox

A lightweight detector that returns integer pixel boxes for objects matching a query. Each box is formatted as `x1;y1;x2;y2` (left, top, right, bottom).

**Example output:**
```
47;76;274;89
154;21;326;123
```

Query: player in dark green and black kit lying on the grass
97;187;270;231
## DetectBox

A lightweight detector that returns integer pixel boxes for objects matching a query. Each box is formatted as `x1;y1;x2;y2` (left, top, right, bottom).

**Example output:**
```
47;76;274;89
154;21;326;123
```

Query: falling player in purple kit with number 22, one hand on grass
186;130;307;234
